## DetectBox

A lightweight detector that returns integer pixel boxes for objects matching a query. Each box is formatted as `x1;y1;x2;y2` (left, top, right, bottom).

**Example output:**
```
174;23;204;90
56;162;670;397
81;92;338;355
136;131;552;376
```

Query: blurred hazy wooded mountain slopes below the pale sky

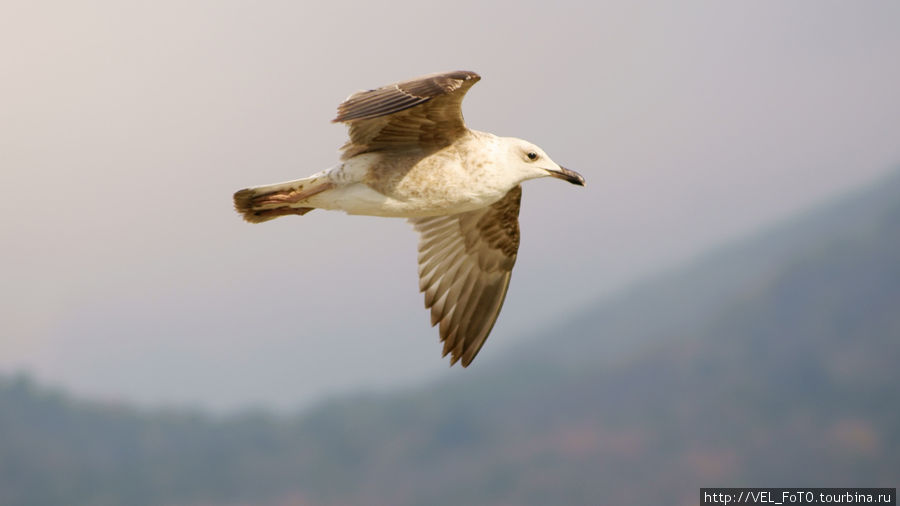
0;170;900;506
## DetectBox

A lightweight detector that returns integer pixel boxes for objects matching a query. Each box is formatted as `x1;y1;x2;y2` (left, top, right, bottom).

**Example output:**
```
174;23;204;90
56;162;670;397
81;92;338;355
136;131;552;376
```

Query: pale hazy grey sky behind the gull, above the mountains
0;0;900;409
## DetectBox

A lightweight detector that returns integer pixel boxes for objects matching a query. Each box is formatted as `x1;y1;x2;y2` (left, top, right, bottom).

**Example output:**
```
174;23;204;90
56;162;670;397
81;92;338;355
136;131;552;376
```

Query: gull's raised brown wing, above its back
333;70;481;160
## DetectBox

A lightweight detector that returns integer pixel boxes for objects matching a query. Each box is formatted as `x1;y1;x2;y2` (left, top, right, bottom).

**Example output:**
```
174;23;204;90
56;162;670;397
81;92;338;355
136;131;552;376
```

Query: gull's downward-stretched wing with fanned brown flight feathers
410;186;522;367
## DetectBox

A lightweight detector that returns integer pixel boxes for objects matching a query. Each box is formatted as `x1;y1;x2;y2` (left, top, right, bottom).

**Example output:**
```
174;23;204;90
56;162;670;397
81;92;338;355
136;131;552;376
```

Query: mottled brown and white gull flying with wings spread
234;70;584;367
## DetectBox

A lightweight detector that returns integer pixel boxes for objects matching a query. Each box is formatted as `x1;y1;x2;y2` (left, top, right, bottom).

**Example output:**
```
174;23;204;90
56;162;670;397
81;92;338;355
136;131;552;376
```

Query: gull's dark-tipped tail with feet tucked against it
234;172;334;223
